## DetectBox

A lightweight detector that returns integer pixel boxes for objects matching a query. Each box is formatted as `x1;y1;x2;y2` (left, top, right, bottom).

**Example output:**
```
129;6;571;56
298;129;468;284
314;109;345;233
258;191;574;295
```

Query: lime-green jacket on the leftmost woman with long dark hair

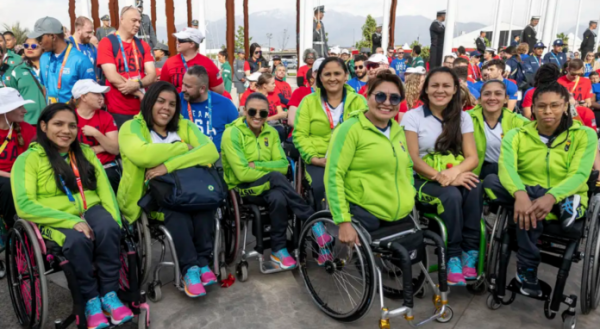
10;142;121;246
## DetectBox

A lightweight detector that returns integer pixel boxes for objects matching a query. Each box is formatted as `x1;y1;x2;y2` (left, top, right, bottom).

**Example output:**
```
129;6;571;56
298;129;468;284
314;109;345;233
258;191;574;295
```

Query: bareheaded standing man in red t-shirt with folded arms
97;7;156;127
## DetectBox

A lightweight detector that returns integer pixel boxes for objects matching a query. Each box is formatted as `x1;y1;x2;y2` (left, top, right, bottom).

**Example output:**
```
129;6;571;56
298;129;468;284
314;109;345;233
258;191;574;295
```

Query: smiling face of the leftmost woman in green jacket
40;110;77;153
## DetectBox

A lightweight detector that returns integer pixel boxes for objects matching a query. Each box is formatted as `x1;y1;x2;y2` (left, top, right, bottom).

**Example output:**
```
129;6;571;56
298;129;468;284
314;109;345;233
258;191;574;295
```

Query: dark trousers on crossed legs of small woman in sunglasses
237;172;314;252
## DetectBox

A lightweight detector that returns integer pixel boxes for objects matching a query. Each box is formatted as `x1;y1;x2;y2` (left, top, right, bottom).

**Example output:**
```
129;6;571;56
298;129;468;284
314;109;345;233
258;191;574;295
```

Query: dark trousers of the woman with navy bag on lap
159;208;215;275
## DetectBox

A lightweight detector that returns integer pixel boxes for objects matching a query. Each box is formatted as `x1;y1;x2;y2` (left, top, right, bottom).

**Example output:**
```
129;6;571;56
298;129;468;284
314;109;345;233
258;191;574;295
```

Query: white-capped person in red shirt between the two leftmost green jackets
72;79;121;193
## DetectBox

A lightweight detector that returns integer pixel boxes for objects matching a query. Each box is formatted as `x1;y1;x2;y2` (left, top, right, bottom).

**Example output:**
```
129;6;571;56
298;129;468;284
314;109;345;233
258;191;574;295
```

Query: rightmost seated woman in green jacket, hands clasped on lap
483;80;598;297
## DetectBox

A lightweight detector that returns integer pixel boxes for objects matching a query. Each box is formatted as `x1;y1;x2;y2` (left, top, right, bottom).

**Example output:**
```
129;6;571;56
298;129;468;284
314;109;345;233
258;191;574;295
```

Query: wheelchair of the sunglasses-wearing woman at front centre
298;210;454;328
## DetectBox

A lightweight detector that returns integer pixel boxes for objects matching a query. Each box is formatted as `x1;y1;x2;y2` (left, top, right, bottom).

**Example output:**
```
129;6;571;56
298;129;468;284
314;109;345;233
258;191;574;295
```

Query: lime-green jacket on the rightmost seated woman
498;121;598;219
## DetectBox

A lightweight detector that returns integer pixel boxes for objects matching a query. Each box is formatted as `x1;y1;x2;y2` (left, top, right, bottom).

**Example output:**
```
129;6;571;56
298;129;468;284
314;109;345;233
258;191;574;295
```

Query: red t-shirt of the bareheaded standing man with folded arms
96;38;154;115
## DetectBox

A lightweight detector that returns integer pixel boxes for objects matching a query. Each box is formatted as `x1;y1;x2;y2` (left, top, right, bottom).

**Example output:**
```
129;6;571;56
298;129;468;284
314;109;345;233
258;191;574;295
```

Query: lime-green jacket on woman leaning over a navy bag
117;113;219;223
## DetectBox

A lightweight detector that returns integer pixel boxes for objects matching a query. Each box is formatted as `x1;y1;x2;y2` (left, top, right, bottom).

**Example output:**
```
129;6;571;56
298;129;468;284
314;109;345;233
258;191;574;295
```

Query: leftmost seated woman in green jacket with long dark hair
11;103;133;328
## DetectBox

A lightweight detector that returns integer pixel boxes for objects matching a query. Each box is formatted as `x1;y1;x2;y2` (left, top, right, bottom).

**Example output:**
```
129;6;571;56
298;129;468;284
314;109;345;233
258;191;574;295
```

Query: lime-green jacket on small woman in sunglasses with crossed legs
221;117;289;190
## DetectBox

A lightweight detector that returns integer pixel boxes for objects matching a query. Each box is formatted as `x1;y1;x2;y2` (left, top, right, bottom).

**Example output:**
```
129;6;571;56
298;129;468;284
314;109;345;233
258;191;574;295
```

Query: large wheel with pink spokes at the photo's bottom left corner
6;219;48;329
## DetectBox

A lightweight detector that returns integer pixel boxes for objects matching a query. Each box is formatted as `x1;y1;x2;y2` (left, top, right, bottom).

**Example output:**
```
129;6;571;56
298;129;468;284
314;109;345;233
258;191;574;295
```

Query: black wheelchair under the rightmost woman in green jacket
486;179;600;328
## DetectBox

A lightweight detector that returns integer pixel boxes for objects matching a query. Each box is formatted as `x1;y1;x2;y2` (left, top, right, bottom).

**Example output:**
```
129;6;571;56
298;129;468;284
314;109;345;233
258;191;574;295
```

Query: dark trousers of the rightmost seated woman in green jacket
483;175;584;268
